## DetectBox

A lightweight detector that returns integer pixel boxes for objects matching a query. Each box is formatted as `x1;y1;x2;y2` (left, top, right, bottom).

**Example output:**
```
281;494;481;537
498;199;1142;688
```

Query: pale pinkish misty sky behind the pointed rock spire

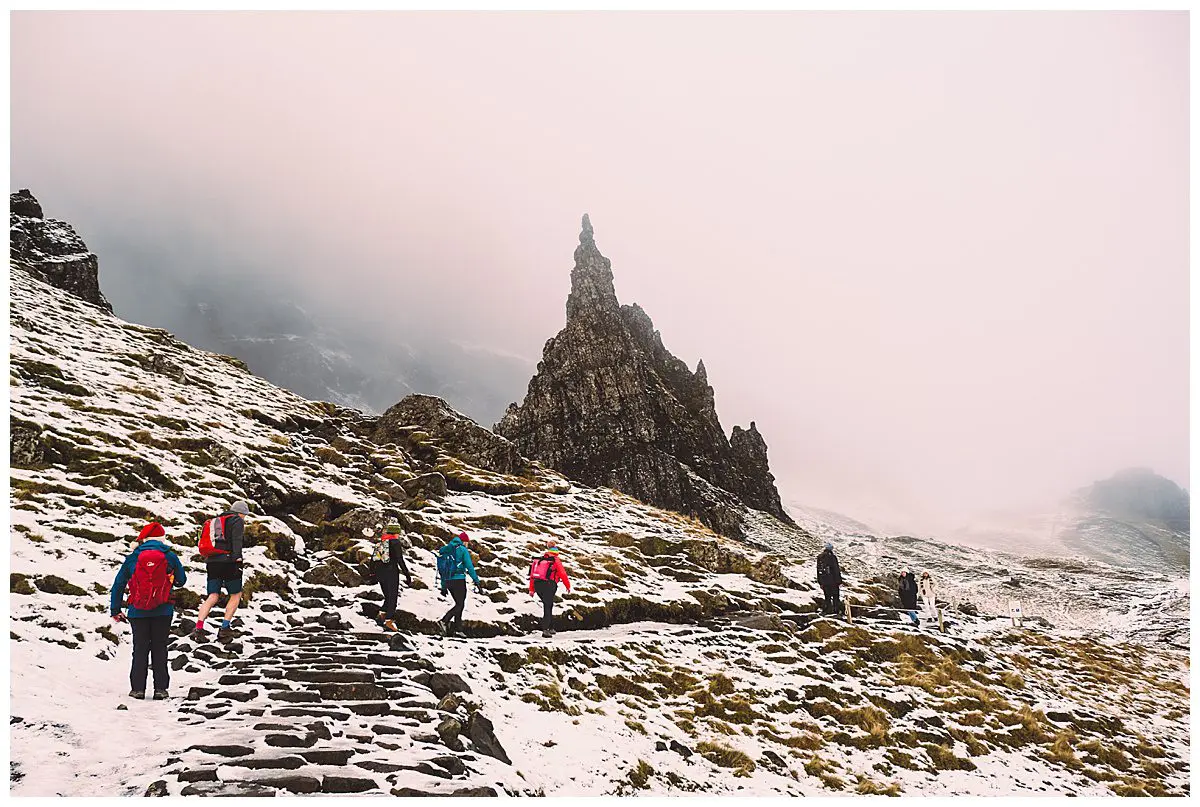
11;12;1189;535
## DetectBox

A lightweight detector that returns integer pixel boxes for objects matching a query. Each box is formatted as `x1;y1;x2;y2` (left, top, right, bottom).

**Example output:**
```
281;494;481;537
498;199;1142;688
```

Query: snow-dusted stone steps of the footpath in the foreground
148;612;513;796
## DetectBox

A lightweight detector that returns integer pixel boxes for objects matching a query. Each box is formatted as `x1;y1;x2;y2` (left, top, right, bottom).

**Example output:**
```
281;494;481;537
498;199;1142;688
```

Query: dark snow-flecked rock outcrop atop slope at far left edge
8;189;113;311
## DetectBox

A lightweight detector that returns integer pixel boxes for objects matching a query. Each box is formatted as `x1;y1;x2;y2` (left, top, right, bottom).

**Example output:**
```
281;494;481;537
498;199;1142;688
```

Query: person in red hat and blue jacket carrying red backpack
109;521;187;700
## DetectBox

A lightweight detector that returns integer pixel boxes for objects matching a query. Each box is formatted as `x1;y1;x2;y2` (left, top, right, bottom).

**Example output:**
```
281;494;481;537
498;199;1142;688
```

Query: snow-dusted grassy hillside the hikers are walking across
10;270;1190;795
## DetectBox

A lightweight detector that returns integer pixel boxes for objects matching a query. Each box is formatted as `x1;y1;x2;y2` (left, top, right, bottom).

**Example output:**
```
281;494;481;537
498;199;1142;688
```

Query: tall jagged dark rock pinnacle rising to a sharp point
496;216;790;536
